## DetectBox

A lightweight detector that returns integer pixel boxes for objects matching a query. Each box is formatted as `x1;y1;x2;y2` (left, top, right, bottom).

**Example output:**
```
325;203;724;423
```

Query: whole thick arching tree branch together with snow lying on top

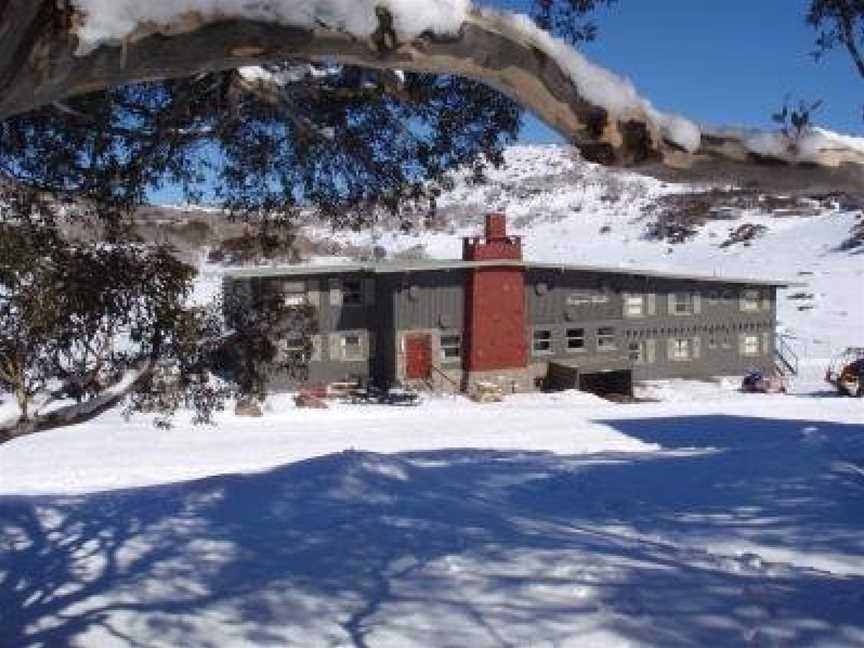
0;0;864;190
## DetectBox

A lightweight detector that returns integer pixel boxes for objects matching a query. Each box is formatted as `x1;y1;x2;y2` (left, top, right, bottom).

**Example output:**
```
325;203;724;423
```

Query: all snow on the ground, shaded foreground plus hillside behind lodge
0;148;864;648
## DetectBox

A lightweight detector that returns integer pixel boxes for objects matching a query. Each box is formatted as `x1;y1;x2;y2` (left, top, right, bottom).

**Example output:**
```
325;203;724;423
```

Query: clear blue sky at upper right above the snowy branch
502;0;864;142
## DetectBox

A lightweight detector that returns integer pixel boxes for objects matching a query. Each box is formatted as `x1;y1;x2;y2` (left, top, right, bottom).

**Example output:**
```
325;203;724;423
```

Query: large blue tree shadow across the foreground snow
0;416;864;647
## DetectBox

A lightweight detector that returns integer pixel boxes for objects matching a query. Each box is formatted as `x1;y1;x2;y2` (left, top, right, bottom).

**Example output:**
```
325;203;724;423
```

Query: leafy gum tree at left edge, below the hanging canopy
0;216;193;441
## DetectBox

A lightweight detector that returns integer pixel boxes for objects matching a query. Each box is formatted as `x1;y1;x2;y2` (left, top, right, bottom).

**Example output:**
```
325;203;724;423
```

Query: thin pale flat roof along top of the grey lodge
224;259;804;288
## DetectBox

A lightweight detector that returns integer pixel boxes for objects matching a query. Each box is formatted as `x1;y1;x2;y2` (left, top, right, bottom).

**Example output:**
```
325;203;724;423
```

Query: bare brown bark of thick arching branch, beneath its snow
0;0;864;191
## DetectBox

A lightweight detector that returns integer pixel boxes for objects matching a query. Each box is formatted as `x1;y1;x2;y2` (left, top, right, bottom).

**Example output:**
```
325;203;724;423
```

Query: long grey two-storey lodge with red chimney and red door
224;214;795;396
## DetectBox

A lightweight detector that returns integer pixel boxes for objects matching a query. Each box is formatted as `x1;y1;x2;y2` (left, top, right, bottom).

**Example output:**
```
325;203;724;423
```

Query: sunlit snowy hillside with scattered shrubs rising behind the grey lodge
328;146;864;360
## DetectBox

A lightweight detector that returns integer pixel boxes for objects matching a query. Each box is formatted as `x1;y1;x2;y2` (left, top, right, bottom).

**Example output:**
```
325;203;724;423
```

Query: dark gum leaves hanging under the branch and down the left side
0;0;610;436
